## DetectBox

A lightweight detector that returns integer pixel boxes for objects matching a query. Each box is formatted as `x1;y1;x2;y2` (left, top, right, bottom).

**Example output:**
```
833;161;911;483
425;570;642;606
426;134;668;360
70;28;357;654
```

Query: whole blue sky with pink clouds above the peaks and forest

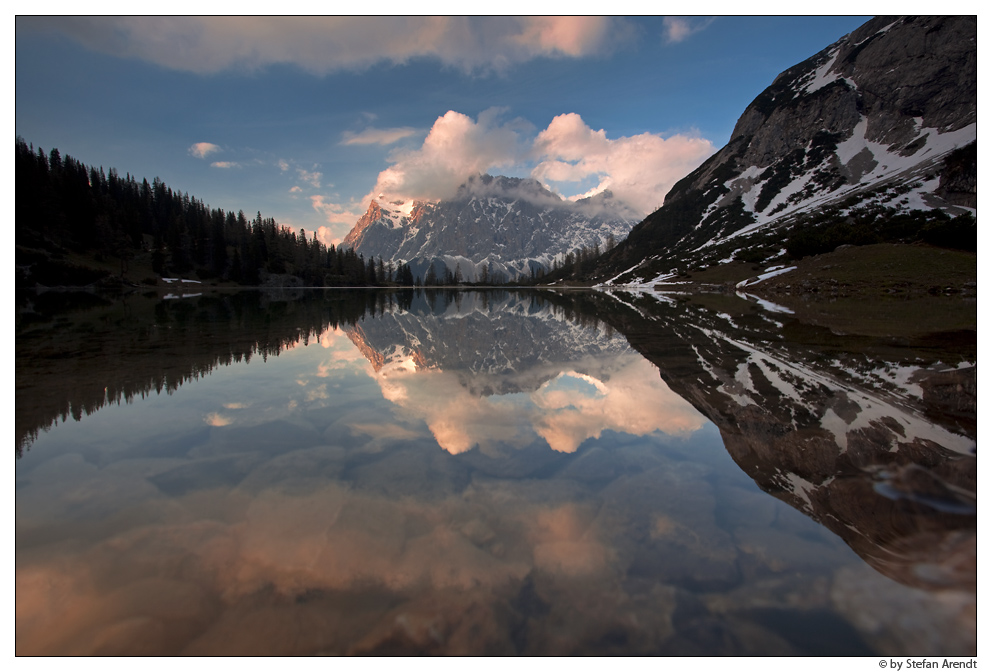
15;16;868;243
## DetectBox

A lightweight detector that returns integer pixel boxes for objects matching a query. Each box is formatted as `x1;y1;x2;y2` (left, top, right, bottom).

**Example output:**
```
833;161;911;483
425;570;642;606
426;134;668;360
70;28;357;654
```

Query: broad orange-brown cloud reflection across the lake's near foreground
15;470;616;655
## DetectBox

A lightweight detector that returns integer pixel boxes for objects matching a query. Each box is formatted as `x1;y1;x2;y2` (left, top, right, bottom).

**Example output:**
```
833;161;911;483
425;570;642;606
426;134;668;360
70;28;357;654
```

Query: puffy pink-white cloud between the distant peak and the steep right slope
531;113;716;214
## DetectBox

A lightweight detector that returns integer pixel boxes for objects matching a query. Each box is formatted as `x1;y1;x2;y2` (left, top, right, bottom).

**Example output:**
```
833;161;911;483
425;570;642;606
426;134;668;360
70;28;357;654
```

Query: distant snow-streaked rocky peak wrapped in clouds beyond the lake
342;175;640;280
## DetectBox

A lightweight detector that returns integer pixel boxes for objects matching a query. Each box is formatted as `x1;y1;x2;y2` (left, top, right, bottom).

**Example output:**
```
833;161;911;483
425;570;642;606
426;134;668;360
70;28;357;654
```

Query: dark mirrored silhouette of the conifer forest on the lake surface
15;290;400;456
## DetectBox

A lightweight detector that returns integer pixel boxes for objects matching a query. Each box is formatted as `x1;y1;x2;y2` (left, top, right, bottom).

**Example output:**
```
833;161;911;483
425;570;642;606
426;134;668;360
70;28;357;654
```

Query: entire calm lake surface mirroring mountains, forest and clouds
16;290;977;656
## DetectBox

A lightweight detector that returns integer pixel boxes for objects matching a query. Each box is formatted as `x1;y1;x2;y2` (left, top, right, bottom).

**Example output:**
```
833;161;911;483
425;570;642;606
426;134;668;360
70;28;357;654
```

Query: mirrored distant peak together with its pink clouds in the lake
346;292;703;453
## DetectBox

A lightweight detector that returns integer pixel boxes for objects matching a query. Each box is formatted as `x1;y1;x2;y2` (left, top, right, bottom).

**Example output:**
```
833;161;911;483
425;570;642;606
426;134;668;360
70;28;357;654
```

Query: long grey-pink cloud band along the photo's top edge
31;16;634;75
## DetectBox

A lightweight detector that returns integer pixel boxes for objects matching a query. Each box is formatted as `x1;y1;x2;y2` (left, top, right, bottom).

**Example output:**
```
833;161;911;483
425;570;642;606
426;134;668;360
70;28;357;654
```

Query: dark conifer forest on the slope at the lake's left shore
15;138;415;286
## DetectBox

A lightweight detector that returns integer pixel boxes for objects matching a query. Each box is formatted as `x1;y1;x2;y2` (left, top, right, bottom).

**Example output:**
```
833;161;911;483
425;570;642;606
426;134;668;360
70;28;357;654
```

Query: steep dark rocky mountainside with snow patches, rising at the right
585;16;977;284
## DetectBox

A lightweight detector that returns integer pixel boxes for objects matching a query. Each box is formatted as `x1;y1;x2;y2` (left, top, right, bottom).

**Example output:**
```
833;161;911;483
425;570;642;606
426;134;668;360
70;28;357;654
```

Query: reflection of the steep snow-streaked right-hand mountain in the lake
556;294;976;592
